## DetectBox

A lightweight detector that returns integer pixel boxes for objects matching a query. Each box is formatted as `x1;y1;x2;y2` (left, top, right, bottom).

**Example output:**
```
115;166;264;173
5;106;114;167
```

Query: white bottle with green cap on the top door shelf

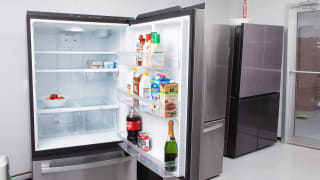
150;34;164;67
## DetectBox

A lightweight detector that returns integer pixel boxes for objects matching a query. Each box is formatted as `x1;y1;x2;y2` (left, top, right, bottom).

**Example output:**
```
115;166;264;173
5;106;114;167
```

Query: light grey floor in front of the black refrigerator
212;143;320;180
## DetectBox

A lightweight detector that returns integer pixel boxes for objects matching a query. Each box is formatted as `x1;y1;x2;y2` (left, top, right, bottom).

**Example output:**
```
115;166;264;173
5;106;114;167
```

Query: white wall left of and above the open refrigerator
0;0;202;177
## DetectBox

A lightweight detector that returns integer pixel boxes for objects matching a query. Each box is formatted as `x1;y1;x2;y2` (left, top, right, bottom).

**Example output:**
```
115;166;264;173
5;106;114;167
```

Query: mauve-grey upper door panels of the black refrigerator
240;24;283;98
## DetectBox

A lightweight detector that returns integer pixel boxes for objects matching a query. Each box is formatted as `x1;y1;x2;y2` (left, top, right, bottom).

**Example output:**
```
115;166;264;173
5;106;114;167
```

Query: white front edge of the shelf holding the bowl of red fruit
38;104;120;114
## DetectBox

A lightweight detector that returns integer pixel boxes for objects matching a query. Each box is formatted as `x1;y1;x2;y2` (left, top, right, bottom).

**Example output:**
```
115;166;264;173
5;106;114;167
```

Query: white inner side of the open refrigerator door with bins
118;16;190;177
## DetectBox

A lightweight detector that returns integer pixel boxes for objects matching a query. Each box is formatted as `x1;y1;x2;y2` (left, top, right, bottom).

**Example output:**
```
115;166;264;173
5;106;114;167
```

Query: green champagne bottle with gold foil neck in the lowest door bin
164;120;178;171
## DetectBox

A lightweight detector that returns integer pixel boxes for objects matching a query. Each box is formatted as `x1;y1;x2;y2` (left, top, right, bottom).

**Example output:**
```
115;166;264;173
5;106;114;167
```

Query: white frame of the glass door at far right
282;6;320;149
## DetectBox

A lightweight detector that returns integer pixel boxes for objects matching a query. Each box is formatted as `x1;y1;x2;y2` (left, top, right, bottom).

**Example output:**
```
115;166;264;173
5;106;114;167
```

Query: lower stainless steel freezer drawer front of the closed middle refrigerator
199;120;225;180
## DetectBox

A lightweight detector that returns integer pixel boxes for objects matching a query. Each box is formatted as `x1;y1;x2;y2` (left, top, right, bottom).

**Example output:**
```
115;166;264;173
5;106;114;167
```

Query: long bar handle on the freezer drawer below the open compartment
42;156;134;174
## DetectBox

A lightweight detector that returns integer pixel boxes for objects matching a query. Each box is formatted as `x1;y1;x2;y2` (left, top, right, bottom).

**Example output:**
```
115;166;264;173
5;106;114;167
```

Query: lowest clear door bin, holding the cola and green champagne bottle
119;137;177;178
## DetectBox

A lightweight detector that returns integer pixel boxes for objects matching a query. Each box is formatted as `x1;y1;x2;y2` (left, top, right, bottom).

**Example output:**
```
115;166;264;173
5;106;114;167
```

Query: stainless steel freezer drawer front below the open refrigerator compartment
33;151;137;180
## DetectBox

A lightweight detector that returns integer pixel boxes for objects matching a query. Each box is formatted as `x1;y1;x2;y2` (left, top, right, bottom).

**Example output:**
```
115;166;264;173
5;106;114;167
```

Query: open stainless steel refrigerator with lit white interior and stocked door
27;4;227;180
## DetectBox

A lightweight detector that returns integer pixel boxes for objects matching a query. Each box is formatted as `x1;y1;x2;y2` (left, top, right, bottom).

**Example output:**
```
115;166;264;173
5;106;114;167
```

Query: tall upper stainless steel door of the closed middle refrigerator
203;24;231;122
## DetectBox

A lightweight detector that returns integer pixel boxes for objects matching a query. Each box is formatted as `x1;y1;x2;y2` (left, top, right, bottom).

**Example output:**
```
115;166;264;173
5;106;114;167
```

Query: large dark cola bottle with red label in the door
127;107;142;144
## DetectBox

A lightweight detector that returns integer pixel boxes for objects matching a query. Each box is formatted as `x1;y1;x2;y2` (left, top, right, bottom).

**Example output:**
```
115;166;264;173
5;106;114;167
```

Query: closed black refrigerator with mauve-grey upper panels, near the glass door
224;24;283;158
